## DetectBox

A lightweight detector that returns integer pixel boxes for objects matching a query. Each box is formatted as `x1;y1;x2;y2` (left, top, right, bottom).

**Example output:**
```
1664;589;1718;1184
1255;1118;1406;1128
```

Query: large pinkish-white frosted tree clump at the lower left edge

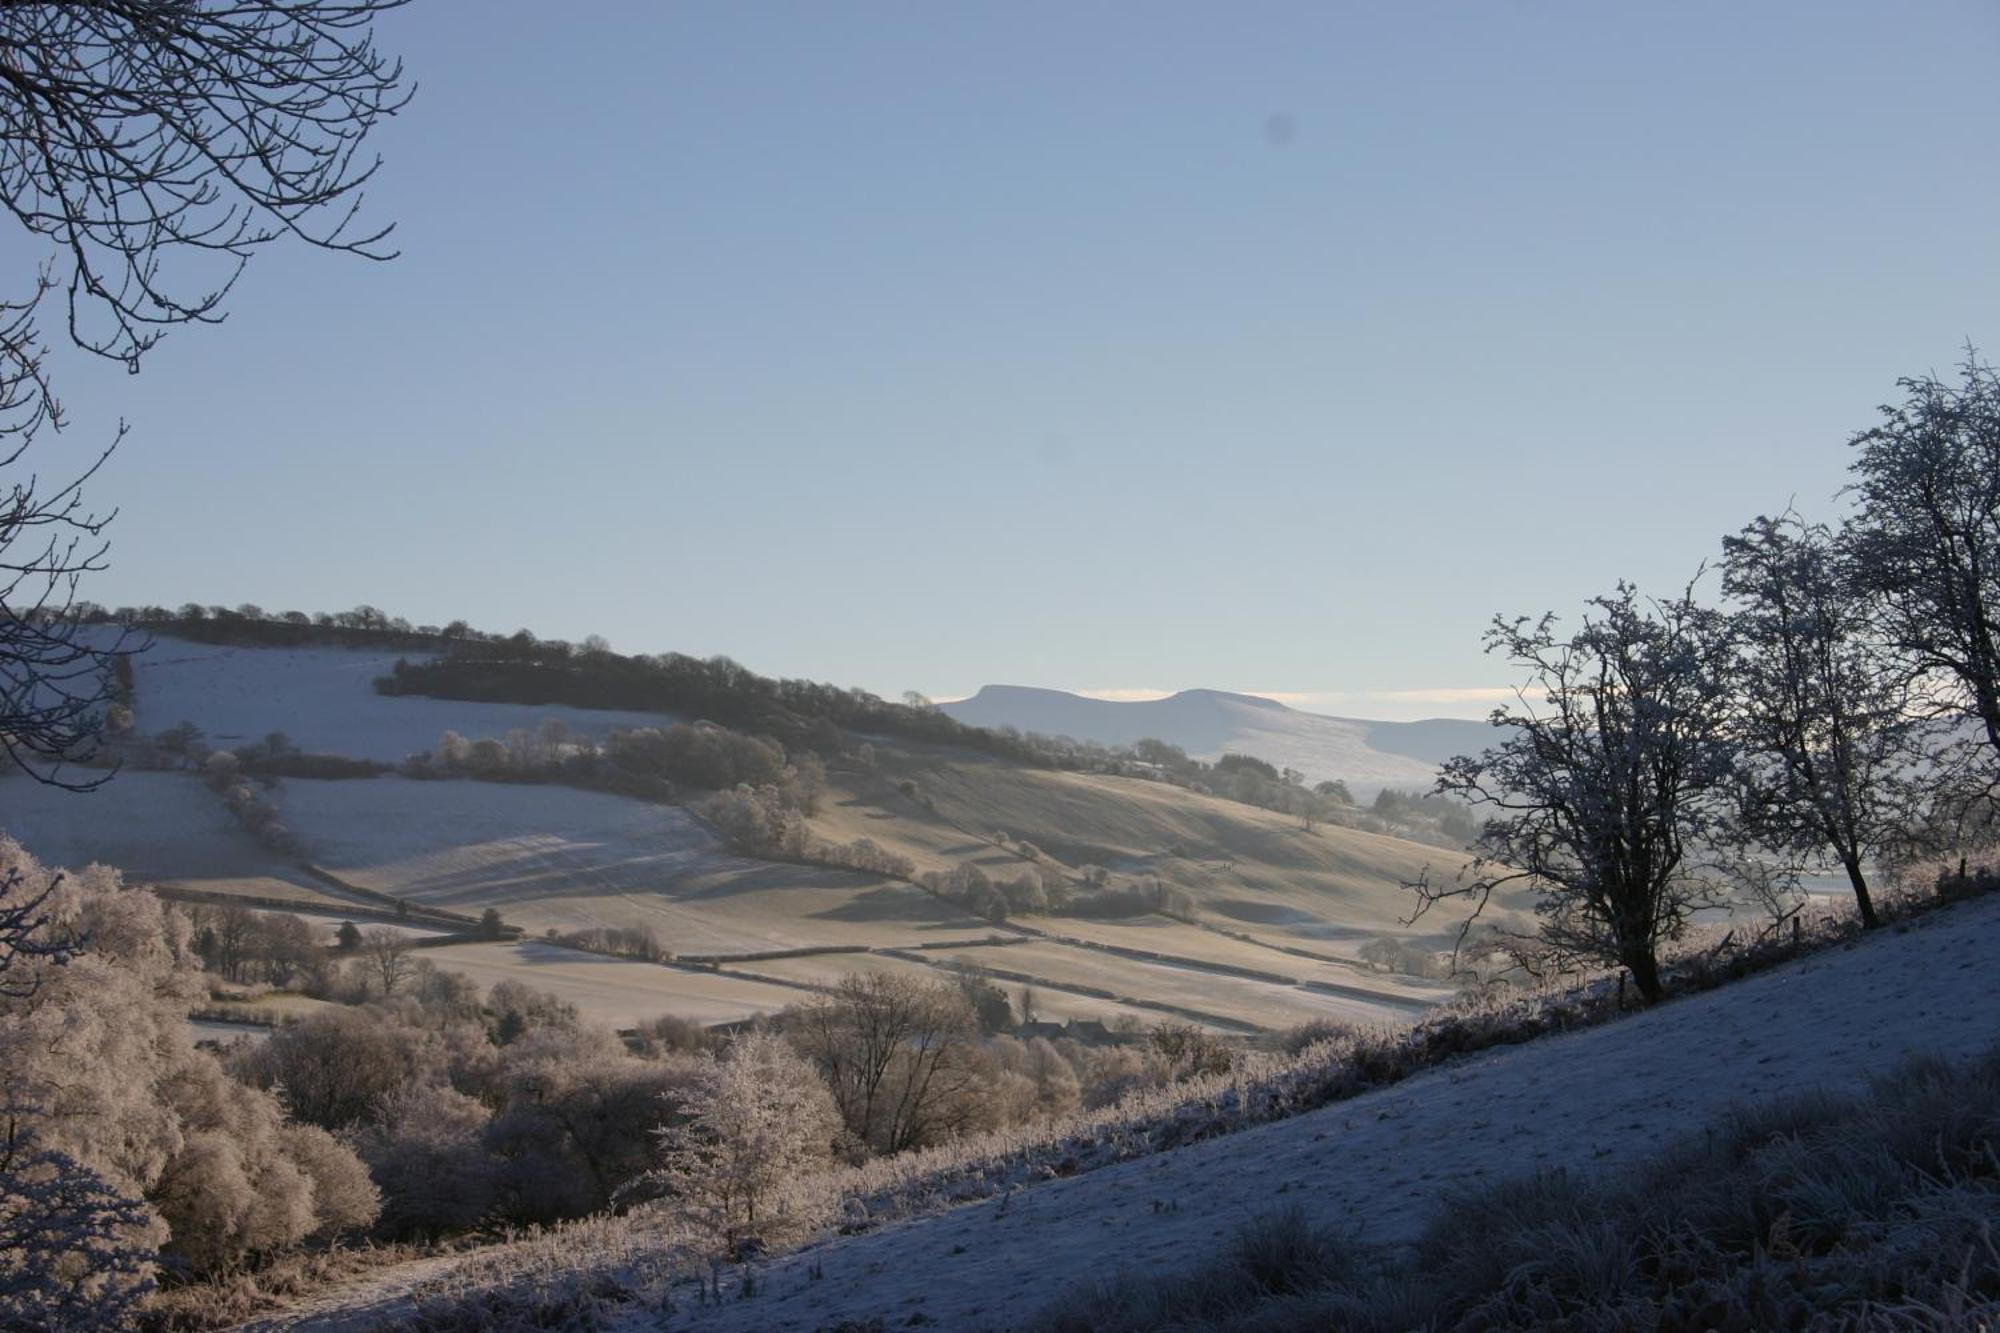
0;839;376;1271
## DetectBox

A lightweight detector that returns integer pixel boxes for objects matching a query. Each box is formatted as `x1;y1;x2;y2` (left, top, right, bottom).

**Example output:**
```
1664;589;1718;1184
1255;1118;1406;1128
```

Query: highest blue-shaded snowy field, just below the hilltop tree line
134;636;668;763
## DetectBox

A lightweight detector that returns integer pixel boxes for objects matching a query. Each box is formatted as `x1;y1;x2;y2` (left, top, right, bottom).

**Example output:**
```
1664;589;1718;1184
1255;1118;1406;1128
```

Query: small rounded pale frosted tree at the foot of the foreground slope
658;1020;840;1257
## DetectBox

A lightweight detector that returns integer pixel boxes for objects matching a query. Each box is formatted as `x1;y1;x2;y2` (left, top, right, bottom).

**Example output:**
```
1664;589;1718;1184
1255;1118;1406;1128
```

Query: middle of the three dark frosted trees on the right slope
1722;514;1916;927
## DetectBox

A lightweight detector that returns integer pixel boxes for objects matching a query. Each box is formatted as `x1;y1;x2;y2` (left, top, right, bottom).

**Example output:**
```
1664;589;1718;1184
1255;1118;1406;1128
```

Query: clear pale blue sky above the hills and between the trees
27;0;2000;717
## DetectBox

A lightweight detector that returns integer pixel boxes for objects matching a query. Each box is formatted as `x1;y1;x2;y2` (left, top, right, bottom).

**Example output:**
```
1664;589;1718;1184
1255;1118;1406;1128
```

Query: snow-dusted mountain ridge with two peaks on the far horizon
938;685;1494;799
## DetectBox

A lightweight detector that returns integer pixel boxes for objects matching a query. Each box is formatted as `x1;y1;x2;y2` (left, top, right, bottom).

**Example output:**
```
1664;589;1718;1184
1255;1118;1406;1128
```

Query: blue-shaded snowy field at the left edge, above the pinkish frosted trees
0;771;334;903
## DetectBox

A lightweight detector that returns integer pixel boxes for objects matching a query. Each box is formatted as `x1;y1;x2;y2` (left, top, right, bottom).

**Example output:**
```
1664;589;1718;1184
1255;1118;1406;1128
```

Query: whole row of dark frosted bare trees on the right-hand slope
1412;348;2000;1003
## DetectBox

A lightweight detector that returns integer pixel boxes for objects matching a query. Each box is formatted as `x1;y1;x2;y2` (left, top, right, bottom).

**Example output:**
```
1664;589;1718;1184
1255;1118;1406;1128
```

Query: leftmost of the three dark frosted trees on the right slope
1412;584;1730;1003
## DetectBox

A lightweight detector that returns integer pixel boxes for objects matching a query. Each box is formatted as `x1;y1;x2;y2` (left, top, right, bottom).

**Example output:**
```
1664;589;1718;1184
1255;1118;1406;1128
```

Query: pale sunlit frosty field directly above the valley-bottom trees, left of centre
420;941;810;1027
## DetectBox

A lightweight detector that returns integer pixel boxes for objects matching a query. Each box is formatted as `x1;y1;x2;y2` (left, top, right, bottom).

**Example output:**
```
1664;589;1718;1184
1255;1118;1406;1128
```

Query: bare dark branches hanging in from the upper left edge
0;0;408;787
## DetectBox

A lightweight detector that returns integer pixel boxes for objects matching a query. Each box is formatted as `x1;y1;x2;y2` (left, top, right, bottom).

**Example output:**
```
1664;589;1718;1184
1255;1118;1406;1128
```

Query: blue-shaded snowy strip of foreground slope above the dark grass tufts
644;899;2000;1333
